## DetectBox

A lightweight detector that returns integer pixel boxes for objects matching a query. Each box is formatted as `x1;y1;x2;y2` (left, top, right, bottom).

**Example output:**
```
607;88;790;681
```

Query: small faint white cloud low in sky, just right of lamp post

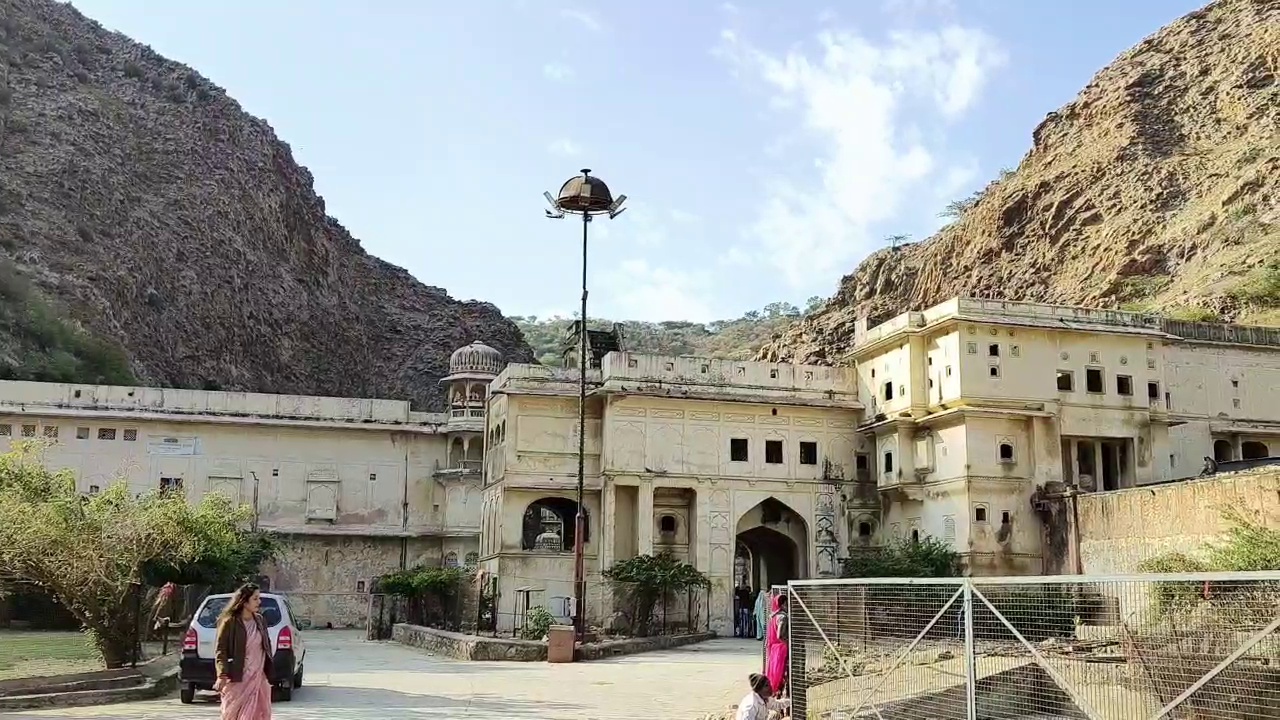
601;260;716;323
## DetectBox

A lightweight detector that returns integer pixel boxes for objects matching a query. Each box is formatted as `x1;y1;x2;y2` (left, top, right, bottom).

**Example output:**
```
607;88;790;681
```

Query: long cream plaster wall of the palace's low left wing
0;414;460;534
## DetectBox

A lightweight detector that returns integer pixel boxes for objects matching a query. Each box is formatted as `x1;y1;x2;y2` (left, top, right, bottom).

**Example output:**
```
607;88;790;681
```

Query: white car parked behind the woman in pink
178;593;307;703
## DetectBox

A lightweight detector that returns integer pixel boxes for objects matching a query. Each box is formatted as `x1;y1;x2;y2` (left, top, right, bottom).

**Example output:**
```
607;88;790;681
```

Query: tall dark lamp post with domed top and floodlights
543;169;627;639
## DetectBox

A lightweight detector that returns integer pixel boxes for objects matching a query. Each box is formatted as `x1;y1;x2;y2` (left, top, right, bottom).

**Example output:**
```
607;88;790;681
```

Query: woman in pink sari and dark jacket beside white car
214;583;271;720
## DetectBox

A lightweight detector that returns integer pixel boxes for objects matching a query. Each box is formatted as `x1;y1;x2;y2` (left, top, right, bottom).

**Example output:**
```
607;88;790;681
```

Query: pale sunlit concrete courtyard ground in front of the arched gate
5;630;760;720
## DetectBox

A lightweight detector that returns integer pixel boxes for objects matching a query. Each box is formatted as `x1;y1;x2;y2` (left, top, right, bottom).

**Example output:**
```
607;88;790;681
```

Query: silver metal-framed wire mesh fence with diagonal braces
787;573;1280;720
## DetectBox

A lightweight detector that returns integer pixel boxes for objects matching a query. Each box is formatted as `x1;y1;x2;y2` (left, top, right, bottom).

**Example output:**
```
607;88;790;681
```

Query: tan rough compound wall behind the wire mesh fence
1068;469;1280;575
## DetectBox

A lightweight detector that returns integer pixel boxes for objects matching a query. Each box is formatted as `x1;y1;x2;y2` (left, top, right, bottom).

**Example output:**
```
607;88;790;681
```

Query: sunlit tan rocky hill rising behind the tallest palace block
760;0;1280;361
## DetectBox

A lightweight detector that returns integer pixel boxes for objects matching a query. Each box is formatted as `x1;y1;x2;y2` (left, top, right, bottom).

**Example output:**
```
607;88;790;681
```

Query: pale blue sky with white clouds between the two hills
72;0;1202;322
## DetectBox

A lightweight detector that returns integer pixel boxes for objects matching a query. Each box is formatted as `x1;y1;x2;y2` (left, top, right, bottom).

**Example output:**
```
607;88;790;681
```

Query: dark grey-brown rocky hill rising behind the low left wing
0;0;531;409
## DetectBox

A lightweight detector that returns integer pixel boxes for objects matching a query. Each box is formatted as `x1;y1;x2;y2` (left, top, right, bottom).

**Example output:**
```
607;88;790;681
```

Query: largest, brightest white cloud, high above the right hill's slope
717;26;1005;287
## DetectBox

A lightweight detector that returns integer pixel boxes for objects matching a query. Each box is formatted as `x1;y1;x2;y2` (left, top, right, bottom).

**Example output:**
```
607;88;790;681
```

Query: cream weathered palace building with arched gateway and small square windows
0;299;1280;630
